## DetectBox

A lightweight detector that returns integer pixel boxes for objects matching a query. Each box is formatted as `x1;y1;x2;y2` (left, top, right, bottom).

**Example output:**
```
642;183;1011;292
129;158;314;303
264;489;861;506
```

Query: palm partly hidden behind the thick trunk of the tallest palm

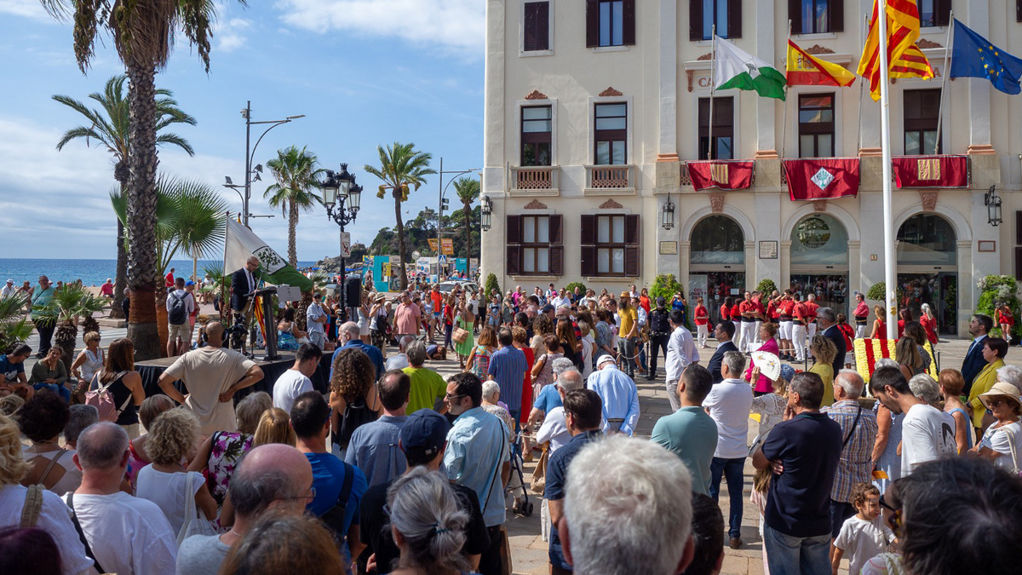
53;75;195;318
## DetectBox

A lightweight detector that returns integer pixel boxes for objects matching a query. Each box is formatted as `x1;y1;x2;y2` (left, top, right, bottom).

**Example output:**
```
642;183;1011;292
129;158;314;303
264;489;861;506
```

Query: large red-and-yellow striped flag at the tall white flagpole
857;0;933;100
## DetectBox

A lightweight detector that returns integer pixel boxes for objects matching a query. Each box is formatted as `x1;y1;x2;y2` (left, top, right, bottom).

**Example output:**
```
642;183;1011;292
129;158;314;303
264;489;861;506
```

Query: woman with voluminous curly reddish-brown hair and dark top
329;347;383;453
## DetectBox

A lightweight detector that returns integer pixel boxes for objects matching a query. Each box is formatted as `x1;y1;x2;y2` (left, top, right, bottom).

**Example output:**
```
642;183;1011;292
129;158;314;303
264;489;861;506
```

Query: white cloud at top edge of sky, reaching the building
277;0;485;57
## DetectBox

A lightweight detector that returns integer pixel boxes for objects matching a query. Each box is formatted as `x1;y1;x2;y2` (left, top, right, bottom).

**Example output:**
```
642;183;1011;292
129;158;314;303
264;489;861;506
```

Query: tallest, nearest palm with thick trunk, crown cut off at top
40;0;244;360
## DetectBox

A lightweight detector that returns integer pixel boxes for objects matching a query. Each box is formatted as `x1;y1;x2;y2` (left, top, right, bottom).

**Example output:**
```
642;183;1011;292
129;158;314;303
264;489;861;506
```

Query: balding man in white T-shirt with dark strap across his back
65;422;178;575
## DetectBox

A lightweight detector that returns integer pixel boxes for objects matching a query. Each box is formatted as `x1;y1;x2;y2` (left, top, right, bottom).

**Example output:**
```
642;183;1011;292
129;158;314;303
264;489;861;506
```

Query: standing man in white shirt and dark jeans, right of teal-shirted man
707;351;752;548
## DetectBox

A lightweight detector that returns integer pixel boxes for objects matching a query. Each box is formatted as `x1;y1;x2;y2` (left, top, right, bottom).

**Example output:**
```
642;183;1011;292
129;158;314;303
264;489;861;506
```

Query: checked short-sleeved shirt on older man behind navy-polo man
822;399;877;504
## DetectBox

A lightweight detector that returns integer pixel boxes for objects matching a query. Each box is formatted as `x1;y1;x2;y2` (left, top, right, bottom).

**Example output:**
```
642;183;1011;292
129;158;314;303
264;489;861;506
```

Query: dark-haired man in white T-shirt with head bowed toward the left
870;368;958;479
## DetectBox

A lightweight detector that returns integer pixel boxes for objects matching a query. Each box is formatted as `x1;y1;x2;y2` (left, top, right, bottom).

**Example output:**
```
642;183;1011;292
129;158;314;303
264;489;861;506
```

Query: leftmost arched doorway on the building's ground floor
689;214;745;323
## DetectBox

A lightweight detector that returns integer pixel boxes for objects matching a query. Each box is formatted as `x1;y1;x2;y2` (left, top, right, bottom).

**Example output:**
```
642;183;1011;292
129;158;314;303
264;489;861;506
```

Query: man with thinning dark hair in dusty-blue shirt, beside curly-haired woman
344;370;412;487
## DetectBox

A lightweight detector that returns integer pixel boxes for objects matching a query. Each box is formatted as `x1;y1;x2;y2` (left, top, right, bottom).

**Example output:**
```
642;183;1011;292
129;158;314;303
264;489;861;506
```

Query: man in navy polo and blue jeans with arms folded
752;373;841;573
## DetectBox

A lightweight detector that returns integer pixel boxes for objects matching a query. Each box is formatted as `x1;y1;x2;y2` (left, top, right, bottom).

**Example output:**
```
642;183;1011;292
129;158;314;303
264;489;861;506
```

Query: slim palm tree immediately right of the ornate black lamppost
365;142;436;290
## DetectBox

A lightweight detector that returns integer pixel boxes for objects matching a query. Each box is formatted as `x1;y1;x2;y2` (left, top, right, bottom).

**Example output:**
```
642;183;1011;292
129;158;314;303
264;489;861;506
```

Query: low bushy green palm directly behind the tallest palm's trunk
110;177;227;353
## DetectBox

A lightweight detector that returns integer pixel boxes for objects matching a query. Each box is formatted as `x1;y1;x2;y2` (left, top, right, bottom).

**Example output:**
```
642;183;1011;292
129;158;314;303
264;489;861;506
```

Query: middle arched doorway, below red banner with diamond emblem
790;213;848;312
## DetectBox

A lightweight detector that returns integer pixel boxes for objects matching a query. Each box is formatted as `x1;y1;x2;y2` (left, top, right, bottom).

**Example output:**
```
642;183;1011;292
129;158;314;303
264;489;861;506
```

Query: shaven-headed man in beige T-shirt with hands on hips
159;322;263;435
